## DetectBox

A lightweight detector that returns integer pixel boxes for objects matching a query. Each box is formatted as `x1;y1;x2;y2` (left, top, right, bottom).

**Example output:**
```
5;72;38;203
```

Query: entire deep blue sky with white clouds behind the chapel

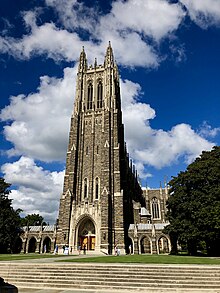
0;0;220;222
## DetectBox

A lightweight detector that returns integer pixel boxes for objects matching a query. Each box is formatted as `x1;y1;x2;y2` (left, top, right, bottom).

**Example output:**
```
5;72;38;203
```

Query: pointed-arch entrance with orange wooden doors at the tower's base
78;217;96;250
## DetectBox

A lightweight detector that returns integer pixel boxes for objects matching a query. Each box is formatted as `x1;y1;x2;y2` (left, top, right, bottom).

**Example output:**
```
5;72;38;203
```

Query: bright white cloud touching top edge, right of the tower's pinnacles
105;0;185;40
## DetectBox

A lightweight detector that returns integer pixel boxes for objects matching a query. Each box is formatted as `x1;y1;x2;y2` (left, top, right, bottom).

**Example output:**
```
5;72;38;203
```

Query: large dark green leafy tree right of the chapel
165;146;220;255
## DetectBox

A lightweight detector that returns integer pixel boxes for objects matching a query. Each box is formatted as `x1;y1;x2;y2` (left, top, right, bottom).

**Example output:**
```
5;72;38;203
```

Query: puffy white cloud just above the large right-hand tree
134;123;214;169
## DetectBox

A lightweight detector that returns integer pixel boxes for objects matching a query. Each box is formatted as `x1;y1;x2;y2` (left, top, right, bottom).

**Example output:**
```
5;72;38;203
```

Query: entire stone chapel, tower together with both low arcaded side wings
16;44;170;254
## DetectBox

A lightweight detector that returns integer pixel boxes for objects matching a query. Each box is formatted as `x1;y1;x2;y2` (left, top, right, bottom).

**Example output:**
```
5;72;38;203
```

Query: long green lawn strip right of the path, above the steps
58;254;220;265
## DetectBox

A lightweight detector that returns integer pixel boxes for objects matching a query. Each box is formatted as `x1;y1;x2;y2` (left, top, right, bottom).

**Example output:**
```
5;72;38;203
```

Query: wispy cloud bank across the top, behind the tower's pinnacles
0;0;185;67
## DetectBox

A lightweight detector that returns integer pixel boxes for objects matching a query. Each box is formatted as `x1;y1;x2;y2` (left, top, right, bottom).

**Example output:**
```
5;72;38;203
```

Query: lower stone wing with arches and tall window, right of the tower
129;186;171;254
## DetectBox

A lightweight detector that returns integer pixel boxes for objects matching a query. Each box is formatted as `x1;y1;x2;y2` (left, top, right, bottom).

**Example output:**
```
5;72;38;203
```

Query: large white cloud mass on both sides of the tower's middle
0;68;218;176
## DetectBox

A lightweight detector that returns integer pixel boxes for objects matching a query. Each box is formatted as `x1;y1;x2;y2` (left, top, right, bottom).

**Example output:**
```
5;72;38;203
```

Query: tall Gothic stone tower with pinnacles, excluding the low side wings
56;43;145;254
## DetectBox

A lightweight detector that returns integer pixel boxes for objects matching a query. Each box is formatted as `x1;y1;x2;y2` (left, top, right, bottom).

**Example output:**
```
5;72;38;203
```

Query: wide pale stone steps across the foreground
0;262;220;292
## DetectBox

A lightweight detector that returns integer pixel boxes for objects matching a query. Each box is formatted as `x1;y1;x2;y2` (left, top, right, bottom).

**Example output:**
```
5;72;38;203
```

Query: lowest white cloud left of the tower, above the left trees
1;157;64;224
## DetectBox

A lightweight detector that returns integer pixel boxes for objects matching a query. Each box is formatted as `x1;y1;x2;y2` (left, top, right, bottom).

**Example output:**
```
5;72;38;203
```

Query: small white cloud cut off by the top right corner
180;0;220;28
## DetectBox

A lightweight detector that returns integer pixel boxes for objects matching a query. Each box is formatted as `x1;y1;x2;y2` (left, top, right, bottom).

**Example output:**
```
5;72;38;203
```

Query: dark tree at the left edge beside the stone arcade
0;178;21;253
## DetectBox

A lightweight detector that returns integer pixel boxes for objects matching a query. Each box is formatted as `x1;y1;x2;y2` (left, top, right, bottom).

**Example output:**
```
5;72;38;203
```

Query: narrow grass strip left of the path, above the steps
0;253;66;261
